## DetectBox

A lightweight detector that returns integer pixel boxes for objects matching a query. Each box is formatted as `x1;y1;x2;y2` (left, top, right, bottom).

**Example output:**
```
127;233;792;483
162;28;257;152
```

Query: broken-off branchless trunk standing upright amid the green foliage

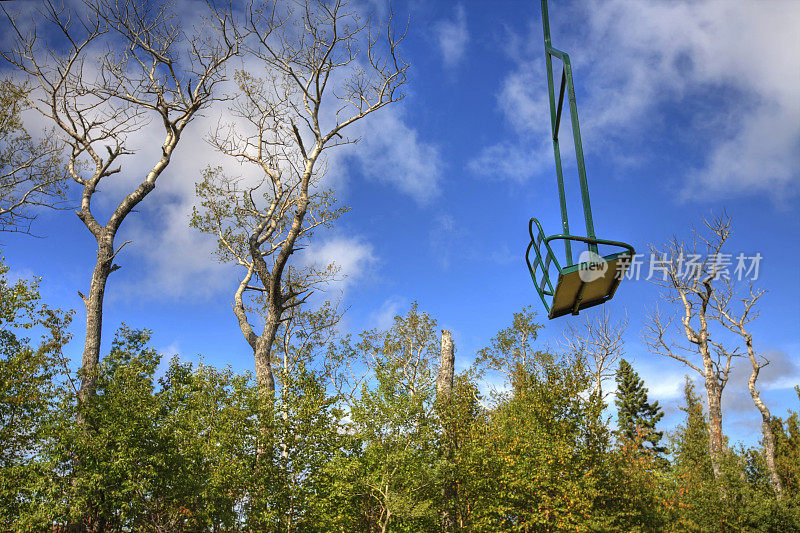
436;329;458;533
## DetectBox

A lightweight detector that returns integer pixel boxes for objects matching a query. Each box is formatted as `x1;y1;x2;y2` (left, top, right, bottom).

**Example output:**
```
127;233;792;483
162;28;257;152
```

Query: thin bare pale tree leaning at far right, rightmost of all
711;279;783;498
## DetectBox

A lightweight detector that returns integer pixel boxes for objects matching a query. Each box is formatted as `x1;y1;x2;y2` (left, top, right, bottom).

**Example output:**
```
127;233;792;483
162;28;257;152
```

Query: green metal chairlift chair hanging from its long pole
525;0;635;319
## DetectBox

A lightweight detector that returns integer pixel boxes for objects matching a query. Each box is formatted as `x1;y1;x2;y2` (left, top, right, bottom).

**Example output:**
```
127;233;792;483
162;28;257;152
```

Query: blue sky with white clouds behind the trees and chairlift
0;0;800;443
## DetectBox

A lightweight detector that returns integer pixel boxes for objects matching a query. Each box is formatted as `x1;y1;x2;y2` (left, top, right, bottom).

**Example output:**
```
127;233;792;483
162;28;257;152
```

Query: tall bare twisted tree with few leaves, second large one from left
192;0;408;404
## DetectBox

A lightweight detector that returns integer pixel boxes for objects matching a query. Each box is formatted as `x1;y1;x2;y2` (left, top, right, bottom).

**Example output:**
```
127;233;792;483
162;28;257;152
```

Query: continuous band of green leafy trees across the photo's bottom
0;286;800;532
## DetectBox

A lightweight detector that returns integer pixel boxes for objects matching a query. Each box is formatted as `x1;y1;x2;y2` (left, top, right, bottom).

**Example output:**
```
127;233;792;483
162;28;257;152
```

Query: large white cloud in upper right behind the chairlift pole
477;0;800;198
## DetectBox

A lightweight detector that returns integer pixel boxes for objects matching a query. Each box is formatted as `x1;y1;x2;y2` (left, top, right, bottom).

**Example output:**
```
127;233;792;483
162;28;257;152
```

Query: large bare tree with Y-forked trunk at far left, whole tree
2;0;239;402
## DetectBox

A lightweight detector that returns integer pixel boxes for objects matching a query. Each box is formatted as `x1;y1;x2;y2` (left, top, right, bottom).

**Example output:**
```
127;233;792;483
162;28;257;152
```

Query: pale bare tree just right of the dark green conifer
645;215;737;479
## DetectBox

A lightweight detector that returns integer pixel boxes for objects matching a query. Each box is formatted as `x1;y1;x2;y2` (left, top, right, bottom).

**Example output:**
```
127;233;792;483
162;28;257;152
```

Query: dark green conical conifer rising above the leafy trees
615;359;666;454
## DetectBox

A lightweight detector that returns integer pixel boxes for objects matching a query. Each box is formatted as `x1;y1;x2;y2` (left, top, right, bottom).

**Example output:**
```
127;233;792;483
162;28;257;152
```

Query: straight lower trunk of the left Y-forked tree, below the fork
78;231;115;405
